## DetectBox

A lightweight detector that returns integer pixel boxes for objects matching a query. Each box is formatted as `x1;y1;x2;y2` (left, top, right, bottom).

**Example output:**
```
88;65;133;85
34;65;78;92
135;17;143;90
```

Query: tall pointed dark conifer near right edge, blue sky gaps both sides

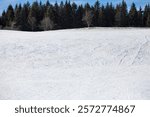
129;3;138;27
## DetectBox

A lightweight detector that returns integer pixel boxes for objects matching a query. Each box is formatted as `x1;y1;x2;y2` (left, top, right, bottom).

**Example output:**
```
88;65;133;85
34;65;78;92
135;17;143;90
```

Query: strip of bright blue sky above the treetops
0;0;150;14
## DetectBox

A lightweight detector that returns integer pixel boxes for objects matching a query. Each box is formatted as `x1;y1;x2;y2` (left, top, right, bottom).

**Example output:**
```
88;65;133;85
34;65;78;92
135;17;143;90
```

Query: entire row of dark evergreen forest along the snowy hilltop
0;0;150;31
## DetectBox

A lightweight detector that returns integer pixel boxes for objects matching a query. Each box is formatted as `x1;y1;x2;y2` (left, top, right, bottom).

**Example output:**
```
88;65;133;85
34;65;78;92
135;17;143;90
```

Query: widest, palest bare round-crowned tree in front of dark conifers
41;17;54;30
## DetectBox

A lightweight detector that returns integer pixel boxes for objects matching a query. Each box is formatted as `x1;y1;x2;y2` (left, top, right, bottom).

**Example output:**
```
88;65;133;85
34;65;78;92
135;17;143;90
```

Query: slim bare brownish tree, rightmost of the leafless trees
83;10;93;28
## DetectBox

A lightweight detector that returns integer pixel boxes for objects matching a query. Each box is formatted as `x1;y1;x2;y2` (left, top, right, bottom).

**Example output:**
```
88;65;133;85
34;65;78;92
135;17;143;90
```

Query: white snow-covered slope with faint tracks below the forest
0;28;150;99
